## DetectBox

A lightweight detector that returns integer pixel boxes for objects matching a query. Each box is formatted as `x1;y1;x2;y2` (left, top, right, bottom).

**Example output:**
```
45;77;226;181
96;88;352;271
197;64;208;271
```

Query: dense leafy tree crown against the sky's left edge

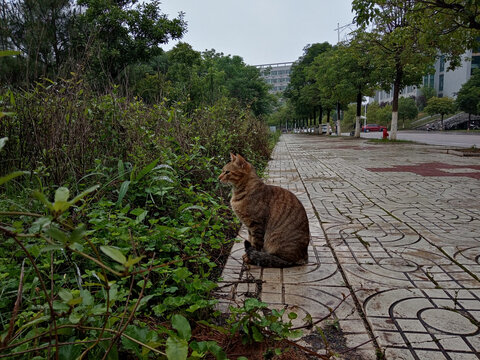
76;0;186;80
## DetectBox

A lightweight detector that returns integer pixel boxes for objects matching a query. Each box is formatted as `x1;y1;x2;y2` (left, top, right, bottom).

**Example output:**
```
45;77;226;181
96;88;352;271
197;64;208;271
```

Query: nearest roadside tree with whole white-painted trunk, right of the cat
352;0;437;140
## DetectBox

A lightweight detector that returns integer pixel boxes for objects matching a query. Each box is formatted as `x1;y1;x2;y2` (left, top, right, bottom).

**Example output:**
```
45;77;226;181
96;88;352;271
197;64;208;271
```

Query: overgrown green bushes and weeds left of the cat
0;74;280;359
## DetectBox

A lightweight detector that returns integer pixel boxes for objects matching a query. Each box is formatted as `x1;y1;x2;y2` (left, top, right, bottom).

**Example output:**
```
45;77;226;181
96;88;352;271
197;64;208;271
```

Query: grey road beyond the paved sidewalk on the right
354;130;480;148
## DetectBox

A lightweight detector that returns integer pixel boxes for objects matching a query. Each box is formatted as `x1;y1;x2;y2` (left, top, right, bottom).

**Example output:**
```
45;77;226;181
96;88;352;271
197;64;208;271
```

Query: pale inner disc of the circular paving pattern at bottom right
419;308;479;335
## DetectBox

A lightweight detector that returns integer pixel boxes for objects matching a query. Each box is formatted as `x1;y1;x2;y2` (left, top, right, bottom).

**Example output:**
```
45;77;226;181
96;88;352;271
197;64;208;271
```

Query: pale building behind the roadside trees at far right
375;50;480;104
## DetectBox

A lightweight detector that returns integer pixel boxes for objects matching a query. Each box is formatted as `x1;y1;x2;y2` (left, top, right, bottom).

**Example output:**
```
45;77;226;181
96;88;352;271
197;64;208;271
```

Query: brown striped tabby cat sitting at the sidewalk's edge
218;154;310;268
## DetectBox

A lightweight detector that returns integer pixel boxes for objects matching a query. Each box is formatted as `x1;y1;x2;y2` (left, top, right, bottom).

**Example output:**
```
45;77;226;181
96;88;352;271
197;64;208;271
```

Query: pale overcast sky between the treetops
161;0;354;65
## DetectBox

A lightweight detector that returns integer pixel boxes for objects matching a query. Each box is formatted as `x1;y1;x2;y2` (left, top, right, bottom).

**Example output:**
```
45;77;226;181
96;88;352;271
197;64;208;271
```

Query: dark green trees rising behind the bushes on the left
0;0;275;115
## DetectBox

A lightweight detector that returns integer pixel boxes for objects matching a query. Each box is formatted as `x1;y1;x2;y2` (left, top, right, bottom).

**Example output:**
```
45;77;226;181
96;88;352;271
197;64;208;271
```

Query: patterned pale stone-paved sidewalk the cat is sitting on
220;135;480;360
